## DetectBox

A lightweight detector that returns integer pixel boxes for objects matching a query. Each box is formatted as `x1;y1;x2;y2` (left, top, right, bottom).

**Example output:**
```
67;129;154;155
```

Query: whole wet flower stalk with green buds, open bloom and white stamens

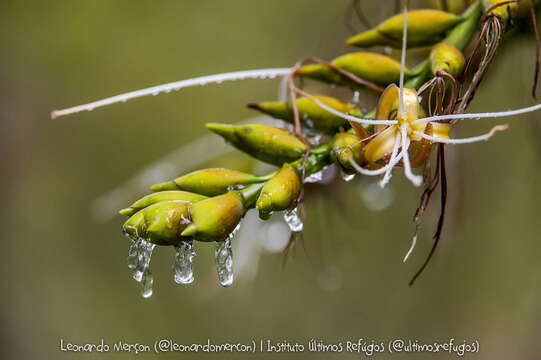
53;0;539;296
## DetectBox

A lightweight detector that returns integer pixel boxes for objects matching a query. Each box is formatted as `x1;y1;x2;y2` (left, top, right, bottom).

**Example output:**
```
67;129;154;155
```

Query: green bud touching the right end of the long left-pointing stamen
299;52;412;88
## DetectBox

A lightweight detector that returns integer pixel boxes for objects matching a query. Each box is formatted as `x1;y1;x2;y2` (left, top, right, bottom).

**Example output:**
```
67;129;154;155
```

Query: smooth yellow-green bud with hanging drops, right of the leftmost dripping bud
181;191;244;241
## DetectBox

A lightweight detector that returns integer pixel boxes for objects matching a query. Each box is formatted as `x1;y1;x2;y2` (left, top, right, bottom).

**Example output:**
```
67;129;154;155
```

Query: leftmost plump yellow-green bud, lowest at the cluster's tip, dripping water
122;200;190;245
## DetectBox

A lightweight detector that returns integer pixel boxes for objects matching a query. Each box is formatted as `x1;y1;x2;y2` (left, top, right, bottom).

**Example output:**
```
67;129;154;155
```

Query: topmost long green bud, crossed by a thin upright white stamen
346;9;463;49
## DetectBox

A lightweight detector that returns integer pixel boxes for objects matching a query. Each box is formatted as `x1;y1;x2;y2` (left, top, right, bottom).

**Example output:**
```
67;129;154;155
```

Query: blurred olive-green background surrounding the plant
0;0;541;359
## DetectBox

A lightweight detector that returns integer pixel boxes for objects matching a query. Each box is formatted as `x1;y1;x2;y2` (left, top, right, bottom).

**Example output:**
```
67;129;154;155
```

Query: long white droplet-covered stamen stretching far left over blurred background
51;68;291;119
